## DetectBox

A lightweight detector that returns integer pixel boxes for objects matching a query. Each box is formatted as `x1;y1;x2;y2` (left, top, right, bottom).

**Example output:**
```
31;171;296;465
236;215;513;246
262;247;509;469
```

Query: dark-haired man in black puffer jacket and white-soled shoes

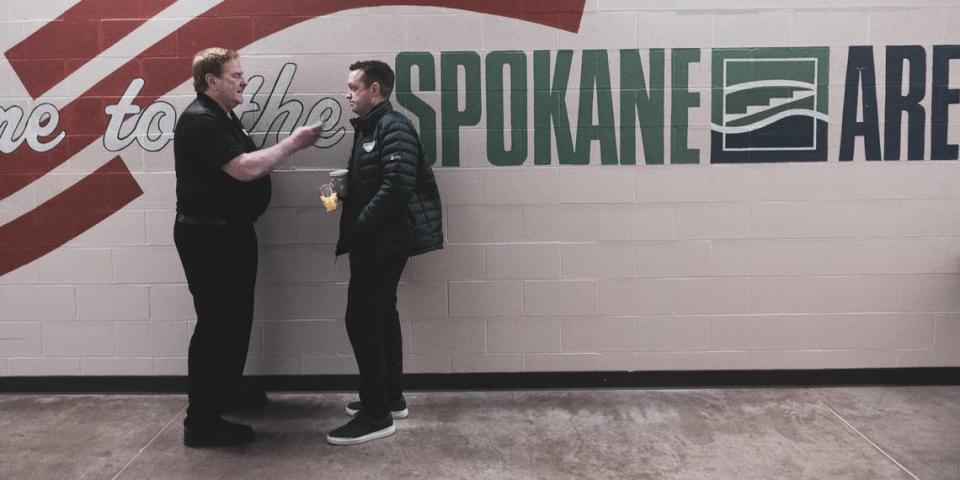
327;61;443;445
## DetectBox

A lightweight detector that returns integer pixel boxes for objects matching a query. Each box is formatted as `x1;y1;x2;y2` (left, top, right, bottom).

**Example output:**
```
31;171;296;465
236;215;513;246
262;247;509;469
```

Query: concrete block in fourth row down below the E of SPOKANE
673;278;750;314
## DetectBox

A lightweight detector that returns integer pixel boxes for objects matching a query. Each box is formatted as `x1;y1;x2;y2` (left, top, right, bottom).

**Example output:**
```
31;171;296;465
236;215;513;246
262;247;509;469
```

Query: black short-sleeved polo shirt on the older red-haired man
173;93;270;223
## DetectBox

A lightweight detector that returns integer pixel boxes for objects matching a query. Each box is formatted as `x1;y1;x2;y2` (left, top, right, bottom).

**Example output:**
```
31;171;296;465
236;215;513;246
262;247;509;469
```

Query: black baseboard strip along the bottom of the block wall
0;367;960;394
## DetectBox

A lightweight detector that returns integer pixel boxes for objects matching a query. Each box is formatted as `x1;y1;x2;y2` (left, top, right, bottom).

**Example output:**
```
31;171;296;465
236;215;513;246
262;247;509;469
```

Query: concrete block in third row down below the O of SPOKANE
484;243;560;280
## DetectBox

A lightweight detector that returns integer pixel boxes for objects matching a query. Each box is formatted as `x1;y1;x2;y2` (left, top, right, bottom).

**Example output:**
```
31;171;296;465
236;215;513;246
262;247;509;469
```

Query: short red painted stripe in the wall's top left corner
5;0;176;98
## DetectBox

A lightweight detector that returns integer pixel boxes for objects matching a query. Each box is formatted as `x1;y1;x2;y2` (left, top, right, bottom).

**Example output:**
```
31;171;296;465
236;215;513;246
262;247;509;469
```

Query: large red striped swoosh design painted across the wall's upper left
0;0;586;275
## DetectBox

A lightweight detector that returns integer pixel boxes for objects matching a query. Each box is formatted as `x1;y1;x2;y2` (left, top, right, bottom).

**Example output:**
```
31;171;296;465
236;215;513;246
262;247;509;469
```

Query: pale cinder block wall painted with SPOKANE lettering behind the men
0;0;960;376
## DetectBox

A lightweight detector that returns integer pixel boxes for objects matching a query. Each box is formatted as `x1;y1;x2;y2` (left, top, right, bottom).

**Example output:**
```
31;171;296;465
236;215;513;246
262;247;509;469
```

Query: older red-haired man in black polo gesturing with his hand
173;48;321;447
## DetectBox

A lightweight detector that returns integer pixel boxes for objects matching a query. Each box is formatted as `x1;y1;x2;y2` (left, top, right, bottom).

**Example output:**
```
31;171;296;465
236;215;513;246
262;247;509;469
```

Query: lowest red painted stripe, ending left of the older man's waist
0;157;143;275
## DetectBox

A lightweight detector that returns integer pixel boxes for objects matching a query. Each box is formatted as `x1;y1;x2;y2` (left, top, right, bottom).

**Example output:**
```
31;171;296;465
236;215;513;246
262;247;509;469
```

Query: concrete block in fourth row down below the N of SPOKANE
600;279;673;315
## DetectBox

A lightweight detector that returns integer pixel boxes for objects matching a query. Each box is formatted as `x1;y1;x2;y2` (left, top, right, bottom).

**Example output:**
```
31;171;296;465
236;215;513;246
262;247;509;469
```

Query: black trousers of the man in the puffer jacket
346;247;407;418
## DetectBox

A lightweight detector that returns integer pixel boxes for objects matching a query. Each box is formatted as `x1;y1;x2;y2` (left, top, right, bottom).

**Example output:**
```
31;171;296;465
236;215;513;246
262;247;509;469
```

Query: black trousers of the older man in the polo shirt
173;223;257;421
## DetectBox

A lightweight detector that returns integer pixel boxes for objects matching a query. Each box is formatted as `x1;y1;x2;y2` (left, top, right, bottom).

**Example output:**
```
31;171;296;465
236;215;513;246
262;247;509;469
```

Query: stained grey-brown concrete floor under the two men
0;387;960;480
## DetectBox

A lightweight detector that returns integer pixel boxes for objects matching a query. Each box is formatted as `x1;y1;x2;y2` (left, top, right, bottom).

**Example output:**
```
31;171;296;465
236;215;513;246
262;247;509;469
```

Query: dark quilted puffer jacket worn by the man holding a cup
336;100;443;257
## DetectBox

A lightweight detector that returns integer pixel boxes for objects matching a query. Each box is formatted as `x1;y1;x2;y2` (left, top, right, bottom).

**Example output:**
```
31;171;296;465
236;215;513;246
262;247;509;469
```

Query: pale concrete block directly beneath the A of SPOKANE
558;165;638;203
